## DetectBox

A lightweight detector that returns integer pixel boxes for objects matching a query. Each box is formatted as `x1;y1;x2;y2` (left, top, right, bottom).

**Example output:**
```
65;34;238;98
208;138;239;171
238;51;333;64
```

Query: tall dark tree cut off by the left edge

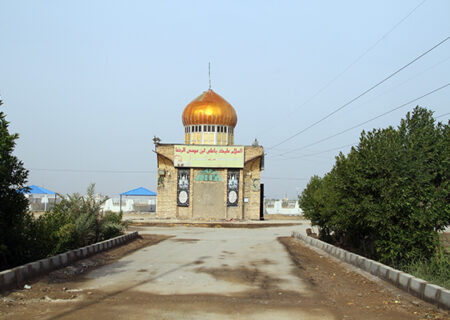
0;101;30;270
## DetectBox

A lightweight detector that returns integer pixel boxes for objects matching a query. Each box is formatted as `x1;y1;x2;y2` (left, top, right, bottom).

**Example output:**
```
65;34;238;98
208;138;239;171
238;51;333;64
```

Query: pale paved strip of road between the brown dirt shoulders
64;226;335;319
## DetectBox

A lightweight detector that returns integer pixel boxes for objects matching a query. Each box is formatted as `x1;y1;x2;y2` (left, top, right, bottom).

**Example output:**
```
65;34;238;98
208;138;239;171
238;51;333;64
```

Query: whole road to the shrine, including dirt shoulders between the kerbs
0;225;442;320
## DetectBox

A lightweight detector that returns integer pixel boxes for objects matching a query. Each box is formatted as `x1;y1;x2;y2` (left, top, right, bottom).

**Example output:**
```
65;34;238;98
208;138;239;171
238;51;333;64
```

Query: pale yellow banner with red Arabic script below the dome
173;145;244;168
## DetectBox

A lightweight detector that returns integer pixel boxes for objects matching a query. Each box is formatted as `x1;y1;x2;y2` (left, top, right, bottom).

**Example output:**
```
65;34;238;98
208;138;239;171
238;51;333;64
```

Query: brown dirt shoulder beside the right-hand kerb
278;237;450;319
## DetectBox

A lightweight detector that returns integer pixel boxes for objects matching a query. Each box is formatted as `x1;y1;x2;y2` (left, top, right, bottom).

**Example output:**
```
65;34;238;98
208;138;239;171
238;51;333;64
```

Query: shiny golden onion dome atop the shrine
182;89;237;128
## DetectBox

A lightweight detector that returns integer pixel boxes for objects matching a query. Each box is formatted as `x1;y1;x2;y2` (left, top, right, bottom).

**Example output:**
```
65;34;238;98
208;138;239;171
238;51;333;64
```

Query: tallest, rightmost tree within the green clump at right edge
376;107;450;264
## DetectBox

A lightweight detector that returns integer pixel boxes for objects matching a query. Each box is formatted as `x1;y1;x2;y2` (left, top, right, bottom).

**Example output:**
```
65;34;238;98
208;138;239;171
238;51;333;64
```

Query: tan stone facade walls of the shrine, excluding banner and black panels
156;144;264;220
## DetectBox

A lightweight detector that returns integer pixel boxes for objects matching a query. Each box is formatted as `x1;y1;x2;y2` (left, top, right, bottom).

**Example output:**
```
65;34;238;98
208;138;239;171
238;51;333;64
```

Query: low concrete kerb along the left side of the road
0;231;138;292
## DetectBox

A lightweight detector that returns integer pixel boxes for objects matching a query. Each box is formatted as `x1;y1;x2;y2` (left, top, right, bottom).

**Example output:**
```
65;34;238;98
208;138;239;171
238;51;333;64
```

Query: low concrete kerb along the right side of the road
292;232;450;309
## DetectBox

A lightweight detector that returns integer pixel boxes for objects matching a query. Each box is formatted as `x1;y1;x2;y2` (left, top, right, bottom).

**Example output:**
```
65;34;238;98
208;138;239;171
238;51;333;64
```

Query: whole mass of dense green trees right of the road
299;107;450;265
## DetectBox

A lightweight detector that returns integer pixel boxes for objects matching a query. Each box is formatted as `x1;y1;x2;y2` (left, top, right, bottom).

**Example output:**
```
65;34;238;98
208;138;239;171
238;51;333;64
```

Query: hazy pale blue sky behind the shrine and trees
0;0;450;198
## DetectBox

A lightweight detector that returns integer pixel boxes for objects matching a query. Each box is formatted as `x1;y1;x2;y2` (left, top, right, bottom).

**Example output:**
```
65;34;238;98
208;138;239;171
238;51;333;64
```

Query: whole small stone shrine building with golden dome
154;89;264;220
